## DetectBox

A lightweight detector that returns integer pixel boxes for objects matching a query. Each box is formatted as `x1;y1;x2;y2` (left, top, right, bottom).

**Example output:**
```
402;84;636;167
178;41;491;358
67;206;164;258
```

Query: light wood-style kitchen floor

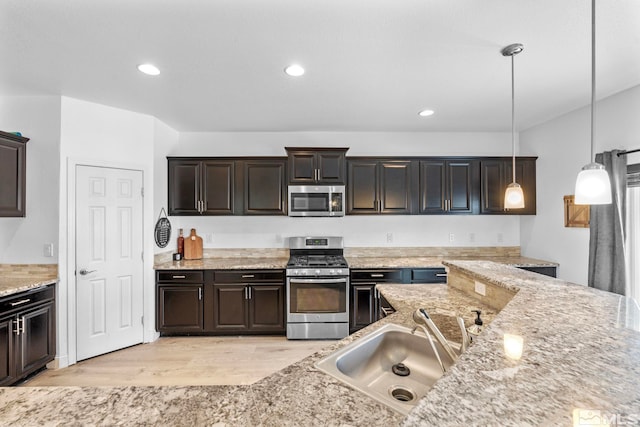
22;336;333;387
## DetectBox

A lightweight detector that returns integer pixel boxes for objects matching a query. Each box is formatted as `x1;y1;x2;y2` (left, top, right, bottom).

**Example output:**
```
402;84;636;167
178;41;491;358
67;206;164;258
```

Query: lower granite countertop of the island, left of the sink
0;284;495;426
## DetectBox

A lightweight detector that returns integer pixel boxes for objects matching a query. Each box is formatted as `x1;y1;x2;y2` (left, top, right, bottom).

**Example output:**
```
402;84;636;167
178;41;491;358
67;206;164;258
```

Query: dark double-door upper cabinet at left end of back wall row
168;158;236;215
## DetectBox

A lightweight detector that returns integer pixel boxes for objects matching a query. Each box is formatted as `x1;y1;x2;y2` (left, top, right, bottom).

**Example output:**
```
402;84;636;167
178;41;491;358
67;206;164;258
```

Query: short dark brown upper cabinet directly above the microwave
286;147;348;185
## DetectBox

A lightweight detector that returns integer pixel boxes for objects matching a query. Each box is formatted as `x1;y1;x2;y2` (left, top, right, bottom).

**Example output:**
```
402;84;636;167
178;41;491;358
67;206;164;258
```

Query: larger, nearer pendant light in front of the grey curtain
574;0;611;205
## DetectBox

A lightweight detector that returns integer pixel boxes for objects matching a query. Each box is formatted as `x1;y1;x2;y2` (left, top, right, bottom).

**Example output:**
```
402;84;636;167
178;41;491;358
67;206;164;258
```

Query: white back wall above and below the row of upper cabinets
168;132;520;249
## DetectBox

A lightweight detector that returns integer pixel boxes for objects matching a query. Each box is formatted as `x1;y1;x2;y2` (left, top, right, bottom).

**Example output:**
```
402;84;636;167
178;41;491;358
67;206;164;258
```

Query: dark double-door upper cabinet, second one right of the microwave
420;158;479;214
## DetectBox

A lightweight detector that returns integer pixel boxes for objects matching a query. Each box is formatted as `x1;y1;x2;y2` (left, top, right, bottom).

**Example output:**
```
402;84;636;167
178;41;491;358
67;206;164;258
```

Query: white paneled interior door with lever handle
76;165;144;360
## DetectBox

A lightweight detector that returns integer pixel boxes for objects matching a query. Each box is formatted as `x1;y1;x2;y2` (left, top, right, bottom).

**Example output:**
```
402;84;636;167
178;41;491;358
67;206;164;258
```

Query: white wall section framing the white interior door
58;97;172;366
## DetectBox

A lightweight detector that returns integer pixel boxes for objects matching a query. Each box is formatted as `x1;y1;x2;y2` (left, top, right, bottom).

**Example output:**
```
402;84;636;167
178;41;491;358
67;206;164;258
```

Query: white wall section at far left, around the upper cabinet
0;96;60;264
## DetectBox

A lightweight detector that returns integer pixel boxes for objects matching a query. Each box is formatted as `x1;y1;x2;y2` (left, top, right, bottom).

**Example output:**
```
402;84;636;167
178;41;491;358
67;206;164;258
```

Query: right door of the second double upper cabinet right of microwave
447;161;478;213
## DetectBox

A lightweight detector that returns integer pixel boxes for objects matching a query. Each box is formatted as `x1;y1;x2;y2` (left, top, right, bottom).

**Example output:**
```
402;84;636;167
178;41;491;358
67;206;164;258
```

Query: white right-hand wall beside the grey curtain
520;86;640;284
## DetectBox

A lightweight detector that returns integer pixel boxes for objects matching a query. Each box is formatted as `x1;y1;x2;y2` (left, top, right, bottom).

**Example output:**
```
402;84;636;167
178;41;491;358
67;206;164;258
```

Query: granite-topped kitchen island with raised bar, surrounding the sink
0;261;640;426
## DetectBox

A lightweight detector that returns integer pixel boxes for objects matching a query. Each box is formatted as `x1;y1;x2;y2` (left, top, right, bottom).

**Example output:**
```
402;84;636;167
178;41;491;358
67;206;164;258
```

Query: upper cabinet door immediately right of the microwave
347;160;378;214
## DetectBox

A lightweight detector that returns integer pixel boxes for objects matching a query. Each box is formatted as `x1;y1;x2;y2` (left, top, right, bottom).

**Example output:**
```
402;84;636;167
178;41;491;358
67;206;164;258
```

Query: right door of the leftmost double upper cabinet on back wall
202;160;235;215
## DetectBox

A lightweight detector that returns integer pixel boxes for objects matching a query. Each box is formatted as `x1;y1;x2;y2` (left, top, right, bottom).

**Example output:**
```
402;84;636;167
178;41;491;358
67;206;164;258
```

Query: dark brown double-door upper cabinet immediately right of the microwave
347;158;417;215
